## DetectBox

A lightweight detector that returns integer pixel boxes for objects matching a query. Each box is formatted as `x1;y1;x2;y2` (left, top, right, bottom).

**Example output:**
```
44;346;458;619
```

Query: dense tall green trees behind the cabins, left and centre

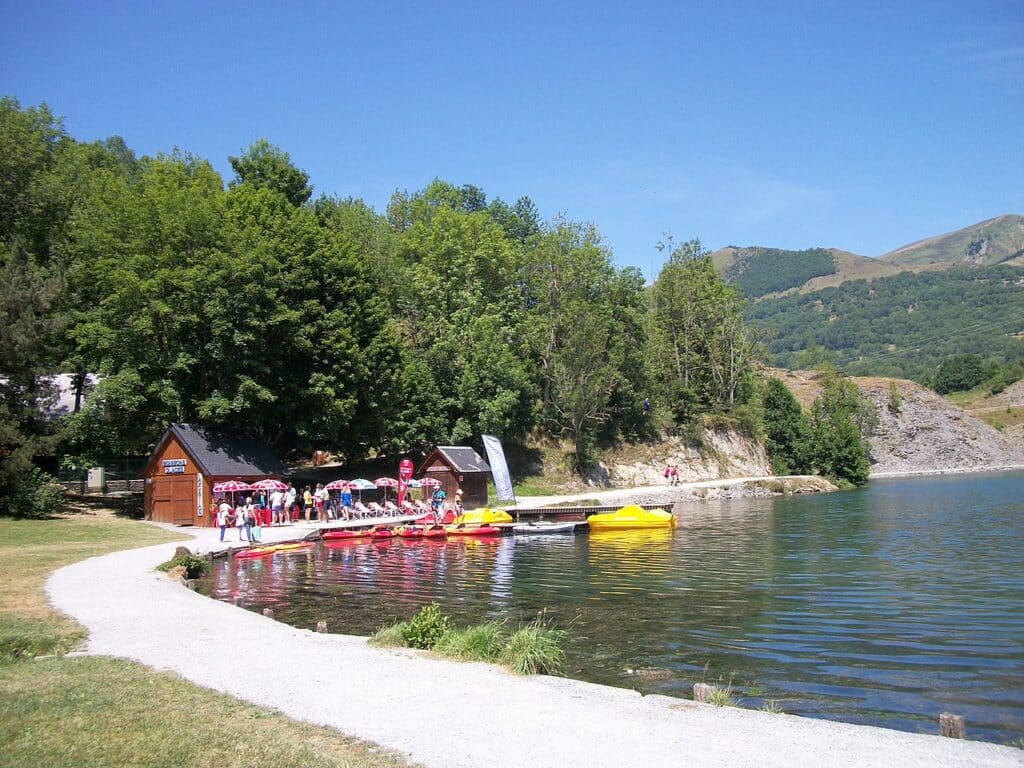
0;99;770;506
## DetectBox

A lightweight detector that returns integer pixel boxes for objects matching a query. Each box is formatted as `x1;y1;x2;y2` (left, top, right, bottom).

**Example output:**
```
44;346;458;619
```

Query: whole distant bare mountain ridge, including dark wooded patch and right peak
712;215;1024;298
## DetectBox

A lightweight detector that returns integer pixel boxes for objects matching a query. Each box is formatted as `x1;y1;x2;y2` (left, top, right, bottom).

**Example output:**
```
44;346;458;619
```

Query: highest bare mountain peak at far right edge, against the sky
879;214;1024;266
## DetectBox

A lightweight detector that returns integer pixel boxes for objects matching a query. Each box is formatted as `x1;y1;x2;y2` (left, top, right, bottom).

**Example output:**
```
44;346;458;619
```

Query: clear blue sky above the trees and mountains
0;0;1024;278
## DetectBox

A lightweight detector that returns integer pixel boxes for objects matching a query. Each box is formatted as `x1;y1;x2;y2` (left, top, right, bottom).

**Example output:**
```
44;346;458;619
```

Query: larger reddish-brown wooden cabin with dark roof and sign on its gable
142;424;285;525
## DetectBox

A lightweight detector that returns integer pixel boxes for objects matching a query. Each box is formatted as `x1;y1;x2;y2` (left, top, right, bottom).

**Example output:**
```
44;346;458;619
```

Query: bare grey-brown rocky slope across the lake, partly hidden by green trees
771;370;1024;475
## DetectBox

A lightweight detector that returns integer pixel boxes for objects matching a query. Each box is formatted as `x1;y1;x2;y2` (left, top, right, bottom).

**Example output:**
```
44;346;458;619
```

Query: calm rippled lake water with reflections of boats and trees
202;473;1024;742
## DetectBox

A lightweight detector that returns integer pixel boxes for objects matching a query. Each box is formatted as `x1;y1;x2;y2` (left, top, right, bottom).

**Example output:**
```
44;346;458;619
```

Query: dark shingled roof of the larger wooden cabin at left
161;424;285;477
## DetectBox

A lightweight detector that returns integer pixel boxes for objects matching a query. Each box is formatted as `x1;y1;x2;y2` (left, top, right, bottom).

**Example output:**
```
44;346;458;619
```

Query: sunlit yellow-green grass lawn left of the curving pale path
0;513;409;768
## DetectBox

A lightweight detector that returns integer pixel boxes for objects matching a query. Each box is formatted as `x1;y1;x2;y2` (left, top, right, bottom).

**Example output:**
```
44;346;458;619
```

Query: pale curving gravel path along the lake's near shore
46;528;1024;768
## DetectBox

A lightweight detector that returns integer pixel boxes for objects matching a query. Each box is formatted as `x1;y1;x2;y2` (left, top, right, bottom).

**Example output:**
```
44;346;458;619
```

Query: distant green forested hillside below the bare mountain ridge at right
745;266;1024;381
